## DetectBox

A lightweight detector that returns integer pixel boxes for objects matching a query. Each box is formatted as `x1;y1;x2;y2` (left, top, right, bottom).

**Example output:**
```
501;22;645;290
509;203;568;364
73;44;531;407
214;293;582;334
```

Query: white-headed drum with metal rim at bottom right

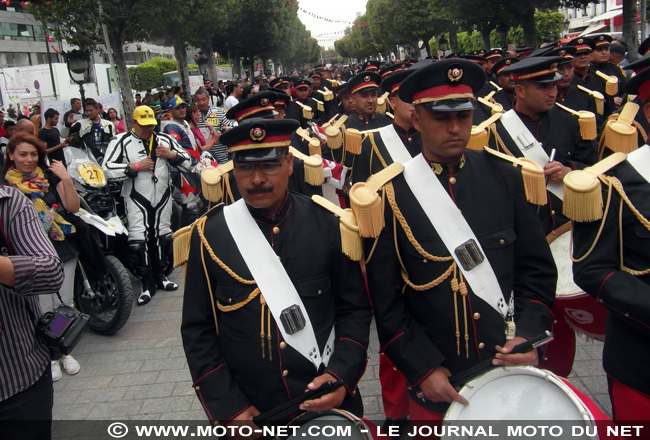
441;366;598;440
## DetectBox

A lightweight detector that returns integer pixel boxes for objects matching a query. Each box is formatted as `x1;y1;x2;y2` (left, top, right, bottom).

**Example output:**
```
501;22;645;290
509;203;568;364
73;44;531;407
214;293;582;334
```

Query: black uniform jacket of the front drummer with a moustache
181;193;370;422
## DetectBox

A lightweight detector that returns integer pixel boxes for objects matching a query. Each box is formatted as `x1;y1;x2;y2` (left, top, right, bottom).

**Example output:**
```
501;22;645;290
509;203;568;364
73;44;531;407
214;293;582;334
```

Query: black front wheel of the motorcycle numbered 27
74;255;133;335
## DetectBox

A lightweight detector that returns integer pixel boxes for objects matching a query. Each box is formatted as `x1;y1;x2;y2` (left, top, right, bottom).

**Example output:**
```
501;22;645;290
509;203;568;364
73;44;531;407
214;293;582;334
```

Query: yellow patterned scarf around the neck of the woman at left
5;167;75;241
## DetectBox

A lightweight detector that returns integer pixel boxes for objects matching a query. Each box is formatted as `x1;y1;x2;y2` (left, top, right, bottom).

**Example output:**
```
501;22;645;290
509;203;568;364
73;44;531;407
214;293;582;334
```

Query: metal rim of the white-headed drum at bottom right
443;365;595;424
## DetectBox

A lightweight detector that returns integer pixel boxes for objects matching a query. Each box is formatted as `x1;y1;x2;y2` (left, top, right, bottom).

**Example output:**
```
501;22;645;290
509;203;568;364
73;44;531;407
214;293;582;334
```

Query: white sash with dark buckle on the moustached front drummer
223;199;334;370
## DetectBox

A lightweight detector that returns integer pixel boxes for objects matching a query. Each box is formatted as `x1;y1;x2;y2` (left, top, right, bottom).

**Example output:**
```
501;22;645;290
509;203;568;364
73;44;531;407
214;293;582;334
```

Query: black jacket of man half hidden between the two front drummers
352;123;422;184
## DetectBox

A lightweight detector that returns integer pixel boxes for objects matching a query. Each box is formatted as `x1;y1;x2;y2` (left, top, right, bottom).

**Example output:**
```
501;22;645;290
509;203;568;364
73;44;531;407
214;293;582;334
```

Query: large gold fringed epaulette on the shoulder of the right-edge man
562;170;603;222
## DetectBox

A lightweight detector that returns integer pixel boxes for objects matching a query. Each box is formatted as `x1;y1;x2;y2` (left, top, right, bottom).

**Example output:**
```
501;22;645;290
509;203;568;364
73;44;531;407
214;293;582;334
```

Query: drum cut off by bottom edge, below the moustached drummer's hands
287;408;377;440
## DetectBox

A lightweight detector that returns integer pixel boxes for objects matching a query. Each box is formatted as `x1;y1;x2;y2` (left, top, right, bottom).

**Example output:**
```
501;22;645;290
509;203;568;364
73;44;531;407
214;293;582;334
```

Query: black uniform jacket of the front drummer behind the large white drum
365;150;557;412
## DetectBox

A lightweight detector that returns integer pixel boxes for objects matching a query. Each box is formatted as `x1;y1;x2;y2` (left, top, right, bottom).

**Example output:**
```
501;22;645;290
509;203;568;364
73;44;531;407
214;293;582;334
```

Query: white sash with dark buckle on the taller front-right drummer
404;154;508;319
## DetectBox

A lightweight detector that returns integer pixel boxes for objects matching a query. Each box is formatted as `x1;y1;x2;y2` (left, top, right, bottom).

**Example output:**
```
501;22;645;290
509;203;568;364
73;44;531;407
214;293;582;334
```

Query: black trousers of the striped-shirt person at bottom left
0;362;54;440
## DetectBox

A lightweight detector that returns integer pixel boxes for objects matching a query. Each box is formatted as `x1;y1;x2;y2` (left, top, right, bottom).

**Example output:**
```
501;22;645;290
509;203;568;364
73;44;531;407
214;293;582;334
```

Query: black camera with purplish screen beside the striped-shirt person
36;304;90;355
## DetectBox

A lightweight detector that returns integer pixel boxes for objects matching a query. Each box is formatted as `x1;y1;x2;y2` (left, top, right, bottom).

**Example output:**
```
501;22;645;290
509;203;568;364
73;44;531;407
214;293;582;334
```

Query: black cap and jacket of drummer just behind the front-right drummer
490;57;597;234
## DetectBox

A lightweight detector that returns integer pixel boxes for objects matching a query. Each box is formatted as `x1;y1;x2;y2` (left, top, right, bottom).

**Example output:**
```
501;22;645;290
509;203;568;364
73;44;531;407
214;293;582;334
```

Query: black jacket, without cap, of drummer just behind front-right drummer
490;106;597;234
